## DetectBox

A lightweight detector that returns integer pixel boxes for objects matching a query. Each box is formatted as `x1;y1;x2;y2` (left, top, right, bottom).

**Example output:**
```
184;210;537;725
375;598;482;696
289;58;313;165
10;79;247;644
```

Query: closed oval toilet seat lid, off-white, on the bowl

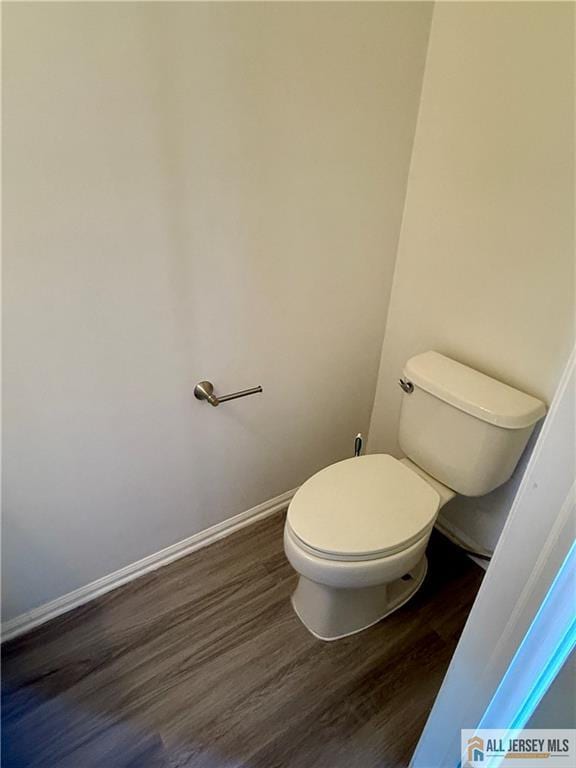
287;453;440;559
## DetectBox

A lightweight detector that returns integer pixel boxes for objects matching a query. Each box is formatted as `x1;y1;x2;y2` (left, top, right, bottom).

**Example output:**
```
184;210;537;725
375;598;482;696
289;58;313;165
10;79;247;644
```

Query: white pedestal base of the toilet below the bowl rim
292;555;428;641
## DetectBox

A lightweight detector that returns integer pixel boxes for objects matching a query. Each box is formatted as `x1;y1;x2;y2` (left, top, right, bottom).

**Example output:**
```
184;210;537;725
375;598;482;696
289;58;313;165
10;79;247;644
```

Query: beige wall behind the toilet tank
369;3;574;548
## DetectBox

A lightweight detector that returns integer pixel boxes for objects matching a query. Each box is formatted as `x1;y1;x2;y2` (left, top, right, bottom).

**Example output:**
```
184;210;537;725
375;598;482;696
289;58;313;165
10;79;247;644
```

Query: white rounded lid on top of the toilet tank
404;352;546;429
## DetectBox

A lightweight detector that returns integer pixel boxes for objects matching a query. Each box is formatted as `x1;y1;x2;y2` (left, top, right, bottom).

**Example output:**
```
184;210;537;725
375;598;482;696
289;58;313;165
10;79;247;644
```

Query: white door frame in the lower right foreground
411;350;576;768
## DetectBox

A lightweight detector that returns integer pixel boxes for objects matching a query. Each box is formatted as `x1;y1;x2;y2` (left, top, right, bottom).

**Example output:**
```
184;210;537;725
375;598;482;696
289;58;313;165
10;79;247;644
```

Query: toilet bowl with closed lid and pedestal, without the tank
284;454;454;640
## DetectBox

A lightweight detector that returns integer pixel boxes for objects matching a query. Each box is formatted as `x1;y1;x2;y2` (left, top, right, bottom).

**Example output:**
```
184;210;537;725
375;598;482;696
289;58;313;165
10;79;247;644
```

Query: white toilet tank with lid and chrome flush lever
399;352;546;496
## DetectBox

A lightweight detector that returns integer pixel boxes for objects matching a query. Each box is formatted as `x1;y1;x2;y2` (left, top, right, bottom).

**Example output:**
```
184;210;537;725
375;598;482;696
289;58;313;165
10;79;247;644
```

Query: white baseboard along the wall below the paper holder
2;488;298;642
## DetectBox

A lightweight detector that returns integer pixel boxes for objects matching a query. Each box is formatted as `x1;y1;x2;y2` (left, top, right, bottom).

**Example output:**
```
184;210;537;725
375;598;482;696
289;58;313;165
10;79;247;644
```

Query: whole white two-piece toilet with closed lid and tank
284;352;546;640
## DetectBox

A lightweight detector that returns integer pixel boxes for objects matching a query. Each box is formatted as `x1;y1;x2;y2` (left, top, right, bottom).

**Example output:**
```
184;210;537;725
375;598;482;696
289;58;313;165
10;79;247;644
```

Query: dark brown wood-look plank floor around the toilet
2;515;483;768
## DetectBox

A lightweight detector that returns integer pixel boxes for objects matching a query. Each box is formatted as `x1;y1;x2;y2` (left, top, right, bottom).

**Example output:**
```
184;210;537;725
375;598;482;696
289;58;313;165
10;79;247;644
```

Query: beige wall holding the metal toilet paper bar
3;3;431;618
